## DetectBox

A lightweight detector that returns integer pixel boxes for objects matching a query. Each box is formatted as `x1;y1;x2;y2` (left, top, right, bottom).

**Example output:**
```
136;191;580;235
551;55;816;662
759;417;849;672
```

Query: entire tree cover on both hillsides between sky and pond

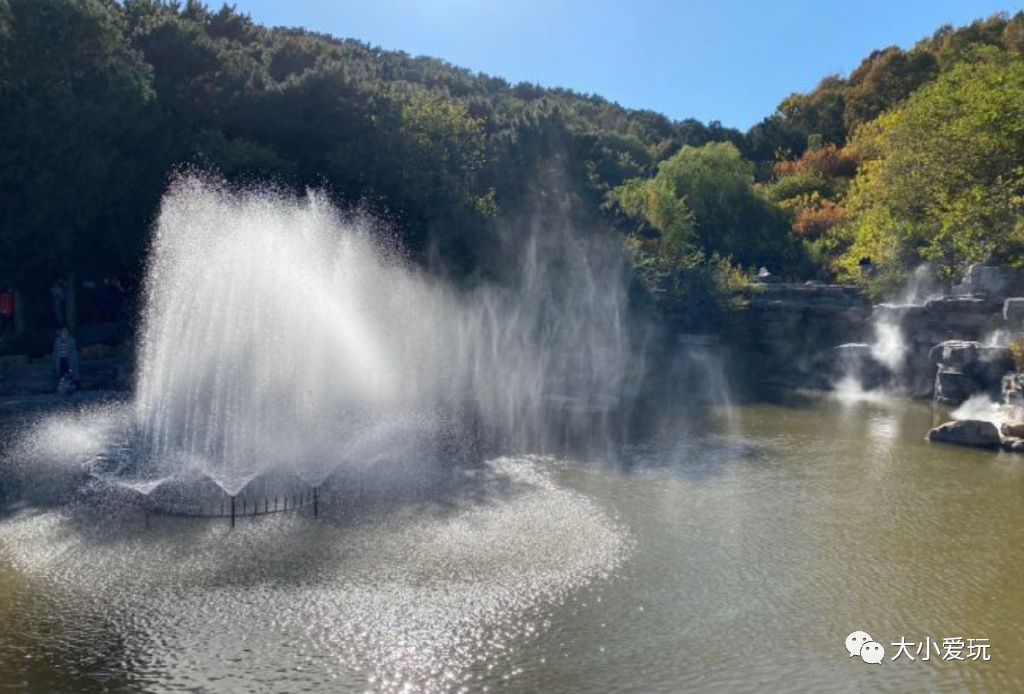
0;0;1024;329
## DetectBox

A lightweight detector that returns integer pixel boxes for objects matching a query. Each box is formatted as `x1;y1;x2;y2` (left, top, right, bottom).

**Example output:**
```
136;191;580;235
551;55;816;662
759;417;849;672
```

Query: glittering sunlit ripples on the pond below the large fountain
0;458;628;692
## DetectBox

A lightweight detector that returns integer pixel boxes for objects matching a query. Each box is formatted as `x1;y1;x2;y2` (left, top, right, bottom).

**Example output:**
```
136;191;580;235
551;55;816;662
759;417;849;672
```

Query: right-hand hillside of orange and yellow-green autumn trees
748;12;1024;289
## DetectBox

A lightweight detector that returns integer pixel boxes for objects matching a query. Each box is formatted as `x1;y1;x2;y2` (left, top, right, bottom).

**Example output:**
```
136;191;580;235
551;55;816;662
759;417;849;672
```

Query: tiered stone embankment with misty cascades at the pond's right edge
726;266;1024;452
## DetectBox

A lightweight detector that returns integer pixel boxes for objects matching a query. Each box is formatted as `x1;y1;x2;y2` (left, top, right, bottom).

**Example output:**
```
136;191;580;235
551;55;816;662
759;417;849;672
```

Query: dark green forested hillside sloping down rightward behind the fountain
0;0;741;292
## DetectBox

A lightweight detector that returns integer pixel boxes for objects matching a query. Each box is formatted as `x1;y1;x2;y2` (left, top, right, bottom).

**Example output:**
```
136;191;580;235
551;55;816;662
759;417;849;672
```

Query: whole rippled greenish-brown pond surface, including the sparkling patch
0;400;1024;692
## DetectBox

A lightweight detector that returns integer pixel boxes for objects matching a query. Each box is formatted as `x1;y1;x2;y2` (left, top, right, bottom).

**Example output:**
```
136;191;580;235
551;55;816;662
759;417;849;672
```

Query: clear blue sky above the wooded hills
234;0;1024;130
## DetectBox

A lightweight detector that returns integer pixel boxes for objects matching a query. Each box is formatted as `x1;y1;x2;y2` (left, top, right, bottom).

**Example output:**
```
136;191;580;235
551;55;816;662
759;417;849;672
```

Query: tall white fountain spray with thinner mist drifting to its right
72;176;637;494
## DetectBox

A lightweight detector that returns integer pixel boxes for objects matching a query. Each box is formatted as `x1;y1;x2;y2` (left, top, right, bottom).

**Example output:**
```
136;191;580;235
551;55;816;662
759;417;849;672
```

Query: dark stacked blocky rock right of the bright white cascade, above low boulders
929;340;1014;406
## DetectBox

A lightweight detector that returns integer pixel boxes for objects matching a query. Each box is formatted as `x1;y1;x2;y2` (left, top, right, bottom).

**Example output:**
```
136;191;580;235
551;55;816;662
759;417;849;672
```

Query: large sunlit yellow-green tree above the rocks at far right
841;47;1024;275
